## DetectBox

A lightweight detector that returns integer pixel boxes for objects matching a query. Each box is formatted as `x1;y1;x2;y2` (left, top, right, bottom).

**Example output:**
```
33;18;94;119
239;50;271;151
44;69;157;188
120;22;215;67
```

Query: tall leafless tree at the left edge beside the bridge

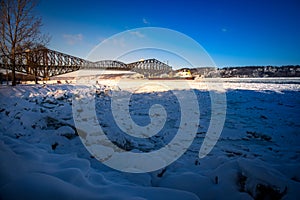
0;0;50;86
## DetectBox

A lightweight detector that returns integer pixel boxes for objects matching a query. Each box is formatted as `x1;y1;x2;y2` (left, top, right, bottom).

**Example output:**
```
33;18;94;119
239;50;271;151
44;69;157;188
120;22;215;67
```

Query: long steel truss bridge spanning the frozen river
0;48;172;79
